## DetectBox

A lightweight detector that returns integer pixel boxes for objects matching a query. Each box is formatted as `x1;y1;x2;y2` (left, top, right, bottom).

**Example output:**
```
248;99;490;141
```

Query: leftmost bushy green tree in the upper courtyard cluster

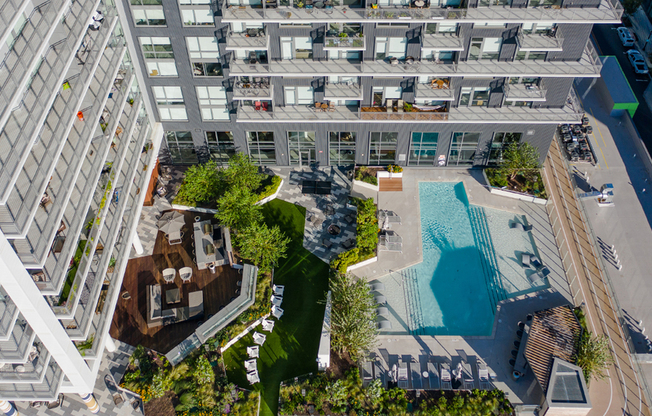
175;161;221;206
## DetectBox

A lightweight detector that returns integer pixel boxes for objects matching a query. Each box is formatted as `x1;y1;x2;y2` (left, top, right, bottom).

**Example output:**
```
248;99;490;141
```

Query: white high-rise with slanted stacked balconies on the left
0;0;163;414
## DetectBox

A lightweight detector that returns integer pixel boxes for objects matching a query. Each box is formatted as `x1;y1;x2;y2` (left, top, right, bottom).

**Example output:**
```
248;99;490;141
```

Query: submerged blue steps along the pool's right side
468;205;507;310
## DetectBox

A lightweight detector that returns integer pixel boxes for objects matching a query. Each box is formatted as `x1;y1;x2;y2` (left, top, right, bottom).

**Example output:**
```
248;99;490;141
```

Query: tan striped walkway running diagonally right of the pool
544;140;650;415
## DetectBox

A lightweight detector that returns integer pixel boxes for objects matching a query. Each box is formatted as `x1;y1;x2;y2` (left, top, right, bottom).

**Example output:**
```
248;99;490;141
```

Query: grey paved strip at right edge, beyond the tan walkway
570;81;652;414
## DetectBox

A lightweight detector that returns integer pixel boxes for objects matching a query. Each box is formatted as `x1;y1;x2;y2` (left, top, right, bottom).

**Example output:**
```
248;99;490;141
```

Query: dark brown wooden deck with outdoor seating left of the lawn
110;211;241;353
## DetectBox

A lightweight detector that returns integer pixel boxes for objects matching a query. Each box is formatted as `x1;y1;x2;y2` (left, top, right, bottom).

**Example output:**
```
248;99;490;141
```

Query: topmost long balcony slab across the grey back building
222;0;623;24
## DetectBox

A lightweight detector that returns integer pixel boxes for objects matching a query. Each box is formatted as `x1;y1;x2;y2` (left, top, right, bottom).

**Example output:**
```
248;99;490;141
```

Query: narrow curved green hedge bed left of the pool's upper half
331;198;379;273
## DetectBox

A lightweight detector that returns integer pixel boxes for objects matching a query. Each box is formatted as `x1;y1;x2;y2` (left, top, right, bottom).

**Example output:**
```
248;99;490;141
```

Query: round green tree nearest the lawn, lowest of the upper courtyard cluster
237;223;290;272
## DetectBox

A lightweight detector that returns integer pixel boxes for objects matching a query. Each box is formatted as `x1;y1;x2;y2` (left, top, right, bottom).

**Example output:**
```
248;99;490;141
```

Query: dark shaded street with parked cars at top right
592;25;652;154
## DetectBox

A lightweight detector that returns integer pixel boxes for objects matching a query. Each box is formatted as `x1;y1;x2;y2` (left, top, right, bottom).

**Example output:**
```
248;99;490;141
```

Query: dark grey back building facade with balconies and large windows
125;0;622;167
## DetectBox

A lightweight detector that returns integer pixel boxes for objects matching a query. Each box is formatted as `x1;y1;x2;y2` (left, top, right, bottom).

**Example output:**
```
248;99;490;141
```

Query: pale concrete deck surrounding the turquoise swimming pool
353;168;572;404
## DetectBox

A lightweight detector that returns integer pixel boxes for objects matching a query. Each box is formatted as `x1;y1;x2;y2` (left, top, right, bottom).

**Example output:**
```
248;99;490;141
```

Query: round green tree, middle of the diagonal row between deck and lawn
215;188;263;231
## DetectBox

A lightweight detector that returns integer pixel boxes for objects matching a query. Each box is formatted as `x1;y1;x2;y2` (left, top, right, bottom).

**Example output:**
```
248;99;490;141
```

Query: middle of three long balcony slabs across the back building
230;42;602;78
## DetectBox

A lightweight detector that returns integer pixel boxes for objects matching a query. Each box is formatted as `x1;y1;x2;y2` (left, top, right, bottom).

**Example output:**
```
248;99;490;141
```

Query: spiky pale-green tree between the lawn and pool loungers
329;271;378;361
